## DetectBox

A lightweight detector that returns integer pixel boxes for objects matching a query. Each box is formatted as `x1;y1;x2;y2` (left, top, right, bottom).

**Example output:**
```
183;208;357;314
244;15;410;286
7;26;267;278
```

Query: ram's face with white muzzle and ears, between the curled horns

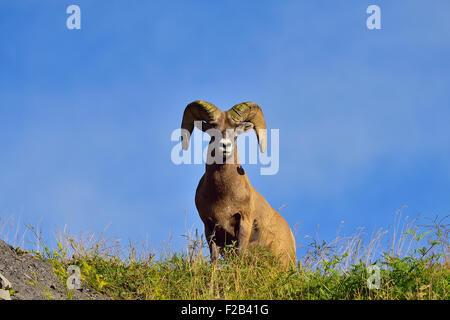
201;113;253;160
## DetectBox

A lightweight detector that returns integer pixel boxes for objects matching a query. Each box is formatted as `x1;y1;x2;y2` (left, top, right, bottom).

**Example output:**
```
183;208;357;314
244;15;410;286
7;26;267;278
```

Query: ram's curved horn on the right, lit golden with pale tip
227;102;267;152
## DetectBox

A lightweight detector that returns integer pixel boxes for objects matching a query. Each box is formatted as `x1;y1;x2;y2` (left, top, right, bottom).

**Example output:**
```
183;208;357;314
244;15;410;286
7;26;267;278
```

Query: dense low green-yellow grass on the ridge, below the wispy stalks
54;248;450;299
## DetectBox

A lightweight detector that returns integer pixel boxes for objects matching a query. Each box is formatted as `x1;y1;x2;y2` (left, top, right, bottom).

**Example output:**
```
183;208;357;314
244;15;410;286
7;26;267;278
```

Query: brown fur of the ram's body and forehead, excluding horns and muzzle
195;113;295;266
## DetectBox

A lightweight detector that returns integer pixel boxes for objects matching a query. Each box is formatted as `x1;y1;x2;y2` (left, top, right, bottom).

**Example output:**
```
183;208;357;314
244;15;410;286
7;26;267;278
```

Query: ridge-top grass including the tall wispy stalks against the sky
0;211;450;300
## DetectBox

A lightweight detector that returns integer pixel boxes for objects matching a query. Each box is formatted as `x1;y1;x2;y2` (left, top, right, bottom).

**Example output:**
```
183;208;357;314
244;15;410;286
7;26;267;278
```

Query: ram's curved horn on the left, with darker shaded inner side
181;100;222;150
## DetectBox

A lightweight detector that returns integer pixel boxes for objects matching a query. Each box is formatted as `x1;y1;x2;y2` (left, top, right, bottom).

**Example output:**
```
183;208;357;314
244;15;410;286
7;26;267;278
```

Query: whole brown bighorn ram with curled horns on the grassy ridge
181;100;296;266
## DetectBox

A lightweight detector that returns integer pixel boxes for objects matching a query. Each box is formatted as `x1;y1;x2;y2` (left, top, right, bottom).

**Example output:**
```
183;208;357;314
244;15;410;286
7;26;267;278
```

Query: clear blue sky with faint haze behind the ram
0;0;450;255
